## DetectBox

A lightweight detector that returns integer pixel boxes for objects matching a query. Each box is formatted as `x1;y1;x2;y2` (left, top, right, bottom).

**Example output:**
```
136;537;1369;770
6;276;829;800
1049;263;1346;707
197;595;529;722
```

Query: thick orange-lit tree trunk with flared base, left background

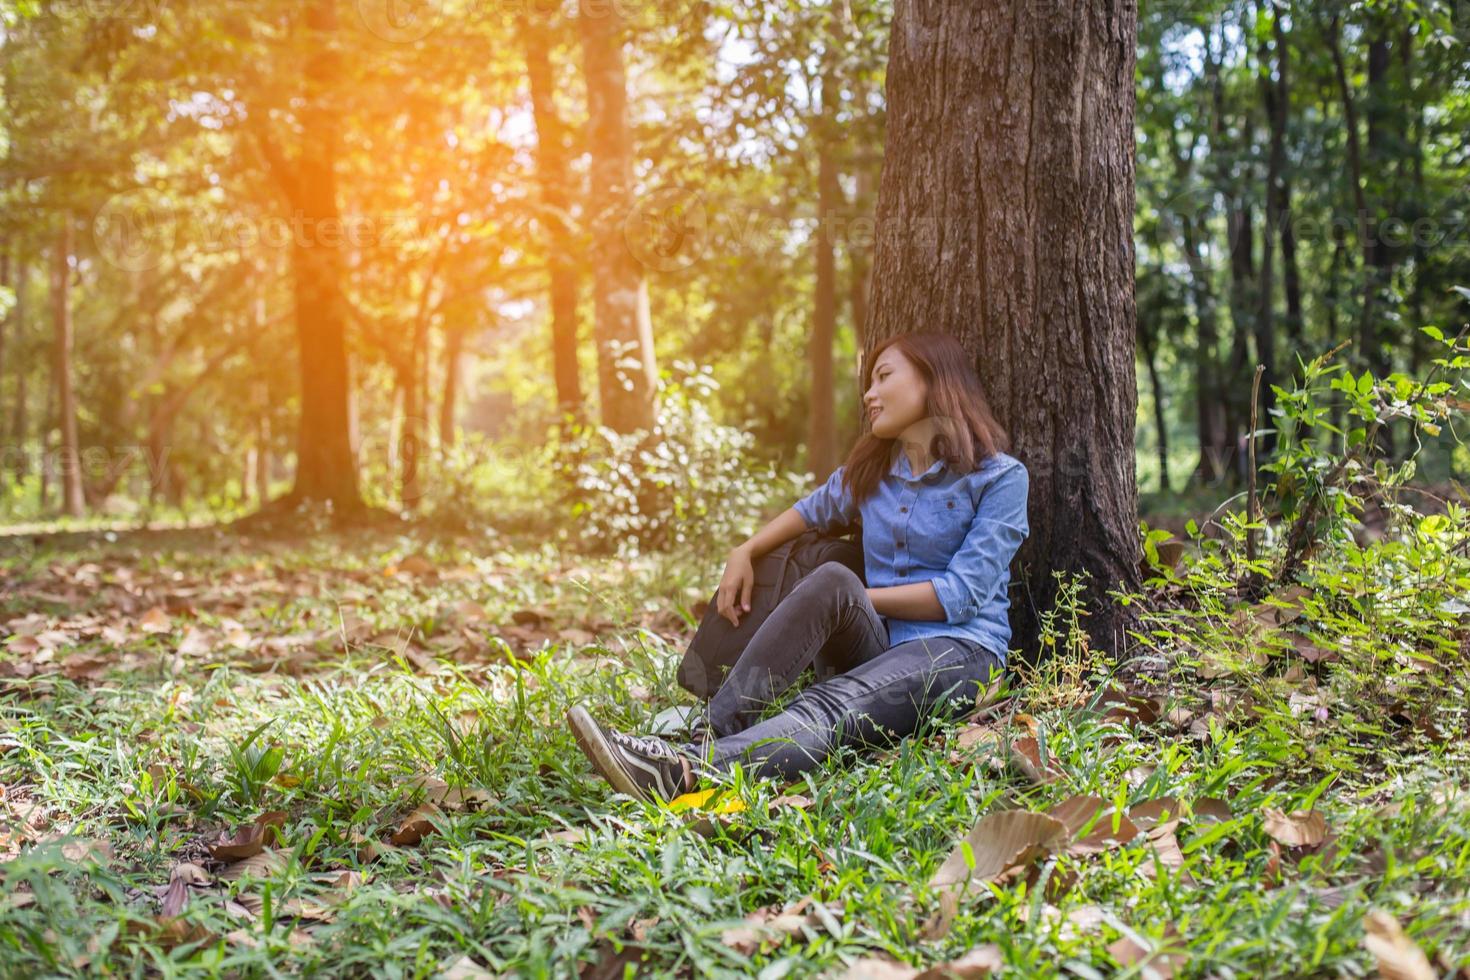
280;0;362;513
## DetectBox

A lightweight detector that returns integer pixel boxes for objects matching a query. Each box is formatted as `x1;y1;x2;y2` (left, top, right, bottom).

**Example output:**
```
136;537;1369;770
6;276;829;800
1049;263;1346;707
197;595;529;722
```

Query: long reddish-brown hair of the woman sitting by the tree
842;332;1010;504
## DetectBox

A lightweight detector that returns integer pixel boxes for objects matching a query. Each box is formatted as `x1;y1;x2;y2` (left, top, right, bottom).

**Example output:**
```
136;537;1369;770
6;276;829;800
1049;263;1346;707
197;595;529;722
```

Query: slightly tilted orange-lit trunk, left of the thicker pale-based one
520;16;587;422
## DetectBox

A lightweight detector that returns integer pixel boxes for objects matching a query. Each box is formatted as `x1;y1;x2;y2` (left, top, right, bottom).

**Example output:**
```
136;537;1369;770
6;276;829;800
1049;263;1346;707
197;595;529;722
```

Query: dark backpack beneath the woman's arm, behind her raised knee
678;525;867;698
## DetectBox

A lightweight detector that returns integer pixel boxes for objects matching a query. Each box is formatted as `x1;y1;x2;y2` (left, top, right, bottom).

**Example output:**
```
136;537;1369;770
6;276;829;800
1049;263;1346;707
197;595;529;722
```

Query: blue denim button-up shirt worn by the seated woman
794;444;1030;664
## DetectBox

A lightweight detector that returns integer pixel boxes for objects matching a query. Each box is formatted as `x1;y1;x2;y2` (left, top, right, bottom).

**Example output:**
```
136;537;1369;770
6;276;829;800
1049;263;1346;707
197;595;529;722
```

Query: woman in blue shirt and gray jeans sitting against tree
567;334;1029;801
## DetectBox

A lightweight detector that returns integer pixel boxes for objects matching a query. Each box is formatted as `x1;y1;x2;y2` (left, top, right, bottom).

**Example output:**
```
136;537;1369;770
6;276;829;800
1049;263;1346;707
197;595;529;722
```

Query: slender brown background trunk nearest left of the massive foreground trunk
807;30;842;482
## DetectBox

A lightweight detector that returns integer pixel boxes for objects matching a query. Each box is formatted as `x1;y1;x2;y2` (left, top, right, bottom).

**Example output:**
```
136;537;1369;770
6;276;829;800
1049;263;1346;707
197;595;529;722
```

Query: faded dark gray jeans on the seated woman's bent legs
706;561;1001;779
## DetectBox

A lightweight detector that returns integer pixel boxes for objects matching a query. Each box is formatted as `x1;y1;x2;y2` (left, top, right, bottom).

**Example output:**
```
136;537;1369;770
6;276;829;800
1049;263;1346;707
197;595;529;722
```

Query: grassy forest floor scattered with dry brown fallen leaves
0;517;1470;980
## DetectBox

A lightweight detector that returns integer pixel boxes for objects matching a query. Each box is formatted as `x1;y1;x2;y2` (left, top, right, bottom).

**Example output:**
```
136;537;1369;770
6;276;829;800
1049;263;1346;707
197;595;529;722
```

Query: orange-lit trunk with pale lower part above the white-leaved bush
576;0;659;432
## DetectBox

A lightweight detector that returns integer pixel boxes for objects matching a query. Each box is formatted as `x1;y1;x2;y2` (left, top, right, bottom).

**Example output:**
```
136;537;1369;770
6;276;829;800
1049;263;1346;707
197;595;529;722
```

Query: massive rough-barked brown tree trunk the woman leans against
869;0;1141;657
